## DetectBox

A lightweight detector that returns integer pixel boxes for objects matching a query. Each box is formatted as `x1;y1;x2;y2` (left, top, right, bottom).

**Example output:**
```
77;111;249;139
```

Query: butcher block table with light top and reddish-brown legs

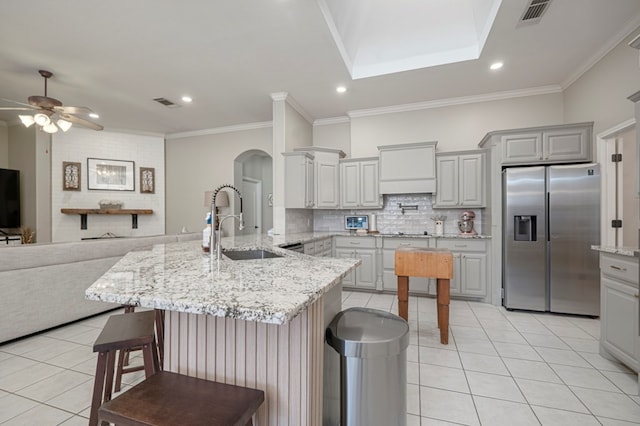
395;247;453;345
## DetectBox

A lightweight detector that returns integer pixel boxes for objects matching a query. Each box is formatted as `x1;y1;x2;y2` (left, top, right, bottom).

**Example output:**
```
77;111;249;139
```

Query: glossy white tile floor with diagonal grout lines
0;292;640;426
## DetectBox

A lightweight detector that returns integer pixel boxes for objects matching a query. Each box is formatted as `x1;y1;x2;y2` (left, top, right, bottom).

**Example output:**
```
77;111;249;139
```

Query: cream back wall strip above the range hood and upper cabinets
351;93;564;158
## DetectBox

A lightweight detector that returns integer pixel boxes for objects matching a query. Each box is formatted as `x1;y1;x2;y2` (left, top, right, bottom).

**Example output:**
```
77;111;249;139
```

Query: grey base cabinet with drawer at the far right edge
600;253;640;372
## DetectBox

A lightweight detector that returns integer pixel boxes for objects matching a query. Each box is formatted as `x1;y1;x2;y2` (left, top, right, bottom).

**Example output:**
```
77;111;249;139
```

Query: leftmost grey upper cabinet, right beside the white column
282;152;315;209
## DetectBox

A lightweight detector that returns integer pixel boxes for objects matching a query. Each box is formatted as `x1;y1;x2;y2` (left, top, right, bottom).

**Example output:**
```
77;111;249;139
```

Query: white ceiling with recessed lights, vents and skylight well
0;0;640;134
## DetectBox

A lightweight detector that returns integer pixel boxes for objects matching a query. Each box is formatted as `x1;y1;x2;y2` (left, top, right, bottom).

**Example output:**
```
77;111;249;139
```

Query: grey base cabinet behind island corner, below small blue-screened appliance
335;237;378;290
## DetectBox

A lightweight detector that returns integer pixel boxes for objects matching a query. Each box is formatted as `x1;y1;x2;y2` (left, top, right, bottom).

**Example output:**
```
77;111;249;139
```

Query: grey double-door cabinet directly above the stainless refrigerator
495;123;593;164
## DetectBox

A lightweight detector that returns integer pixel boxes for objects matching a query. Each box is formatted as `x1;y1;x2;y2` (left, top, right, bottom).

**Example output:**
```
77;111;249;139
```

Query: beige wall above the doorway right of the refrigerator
564;29;640;135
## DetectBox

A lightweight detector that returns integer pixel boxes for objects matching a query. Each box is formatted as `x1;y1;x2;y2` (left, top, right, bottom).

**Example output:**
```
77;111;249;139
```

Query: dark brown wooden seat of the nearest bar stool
98;371;264;426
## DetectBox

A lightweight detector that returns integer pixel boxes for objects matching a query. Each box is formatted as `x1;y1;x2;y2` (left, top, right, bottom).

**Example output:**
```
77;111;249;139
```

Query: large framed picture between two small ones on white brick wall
87;158;135;191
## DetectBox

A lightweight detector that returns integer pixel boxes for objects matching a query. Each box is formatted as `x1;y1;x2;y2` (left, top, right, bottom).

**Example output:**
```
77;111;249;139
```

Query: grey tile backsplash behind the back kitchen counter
313;194;482;234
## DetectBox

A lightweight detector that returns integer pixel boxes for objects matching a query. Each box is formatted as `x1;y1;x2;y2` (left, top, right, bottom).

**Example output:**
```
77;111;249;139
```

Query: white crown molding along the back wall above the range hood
347;85;562;118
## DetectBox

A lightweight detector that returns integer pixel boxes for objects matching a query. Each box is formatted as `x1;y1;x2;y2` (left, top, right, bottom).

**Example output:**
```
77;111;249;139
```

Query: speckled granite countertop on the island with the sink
85;235;361;324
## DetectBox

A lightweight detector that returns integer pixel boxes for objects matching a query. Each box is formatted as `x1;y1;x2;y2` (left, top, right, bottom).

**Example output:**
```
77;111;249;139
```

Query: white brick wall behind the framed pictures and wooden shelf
51;127;165;242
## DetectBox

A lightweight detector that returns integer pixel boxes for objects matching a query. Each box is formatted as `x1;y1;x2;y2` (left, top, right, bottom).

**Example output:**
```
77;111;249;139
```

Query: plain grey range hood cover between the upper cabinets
378;142;437;194
